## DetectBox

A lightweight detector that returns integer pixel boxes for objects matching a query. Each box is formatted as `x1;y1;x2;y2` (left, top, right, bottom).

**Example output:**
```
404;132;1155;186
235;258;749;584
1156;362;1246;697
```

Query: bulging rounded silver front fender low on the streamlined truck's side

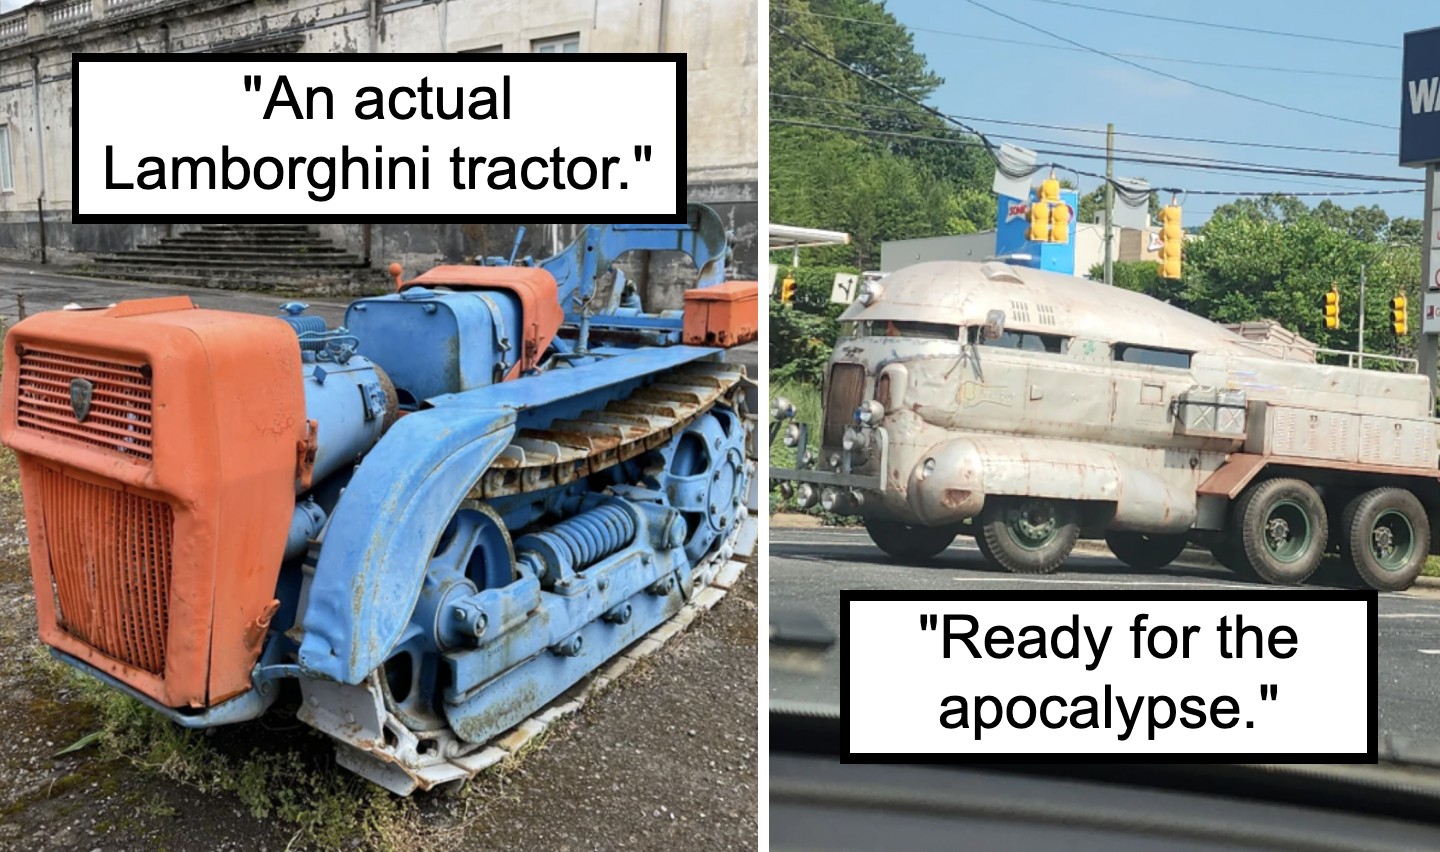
907;436;1195;533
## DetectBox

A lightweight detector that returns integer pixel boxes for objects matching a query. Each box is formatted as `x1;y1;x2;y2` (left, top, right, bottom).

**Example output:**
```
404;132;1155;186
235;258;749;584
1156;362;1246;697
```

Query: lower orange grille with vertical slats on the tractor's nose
39;468;174;675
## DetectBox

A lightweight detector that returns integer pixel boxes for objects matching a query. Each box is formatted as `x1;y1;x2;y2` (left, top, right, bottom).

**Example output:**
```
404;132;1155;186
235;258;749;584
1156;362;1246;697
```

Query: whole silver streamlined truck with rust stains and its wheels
770;262;1440;590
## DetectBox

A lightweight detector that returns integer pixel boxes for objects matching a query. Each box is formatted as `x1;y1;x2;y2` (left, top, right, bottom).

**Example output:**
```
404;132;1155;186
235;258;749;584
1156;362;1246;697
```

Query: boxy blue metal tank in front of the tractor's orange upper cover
346;288;520;404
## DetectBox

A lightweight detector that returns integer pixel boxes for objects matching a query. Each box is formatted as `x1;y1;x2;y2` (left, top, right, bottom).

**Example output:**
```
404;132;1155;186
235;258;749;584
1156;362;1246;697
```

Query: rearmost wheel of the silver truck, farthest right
1341;488;1430;592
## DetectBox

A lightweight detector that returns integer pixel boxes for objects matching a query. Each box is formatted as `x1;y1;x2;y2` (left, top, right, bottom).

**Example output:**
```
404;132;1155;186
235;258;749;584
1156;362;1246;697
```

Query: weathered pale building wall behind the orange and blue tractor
0;0;759;278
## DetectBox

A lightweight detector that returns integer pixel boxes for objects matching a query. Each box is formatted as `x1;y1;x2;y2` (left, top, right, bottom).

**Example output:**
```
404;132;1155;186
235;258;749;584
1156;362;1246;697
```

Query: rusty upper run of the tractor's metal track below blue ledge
468;361;744;499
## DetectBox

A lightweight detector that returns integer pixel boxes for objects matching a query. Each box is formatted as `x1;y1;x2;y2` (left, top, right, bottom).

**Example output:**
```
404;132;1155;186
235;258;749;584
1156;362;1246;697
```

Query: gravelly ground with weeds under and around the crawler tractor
0;453;759;851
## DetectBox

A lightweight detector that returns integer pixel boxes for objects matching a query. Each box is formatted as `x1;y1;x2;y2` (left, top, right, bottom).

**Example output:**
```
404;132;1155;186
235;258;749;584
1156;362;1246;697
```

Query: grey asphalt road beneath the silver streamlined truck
768;525;1440;746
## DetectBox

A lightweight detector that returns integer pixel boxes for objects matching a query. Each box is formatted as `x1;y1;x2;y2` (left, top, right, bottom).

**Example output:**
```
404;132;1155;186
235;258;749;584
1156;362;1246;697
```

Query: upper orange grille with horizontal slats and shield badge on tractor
16;347;151;462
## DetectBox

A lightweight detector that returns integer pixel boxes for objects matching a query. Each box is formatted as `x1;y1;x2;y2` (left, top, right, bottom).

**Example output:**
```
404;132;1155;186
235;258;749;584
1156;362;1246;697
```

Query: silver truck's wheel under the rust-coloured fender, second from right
1234;479;1329;586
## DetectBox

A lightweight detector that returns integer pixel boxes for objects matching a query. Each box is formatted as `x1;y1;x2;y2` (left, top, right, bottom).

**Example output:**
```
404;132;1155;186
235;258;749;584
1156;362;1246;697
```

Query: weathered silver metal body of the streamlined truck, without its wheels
775;262;1440;531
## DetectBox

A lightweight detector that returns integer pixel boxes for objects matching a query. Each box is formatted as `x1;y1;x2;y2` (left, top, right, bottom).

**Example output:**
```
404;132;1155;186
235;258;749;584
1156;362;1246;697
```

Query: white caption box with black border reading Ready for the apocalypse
841;592;1377;761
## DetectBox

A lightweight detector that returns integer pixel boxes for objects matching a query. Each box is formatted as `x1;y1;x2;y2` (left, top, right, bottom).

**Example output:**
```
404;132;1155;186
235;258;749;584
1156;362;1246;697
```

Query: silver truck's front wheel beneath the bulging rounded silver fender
975;497;1080;574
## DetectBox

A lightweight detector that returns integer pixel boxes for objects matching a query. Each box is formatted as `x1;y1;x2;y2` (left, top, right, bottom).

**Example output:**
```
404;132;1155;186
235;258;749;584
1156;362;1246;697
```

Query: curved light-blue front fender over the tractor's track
300;406;516;685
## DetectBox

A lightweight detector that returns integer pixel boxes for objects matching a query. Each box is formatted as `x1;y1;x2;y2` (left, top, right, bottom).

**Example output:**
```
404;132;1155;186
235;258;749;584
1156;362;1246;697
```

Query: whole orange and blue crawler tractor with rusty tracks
0;206;755;794
